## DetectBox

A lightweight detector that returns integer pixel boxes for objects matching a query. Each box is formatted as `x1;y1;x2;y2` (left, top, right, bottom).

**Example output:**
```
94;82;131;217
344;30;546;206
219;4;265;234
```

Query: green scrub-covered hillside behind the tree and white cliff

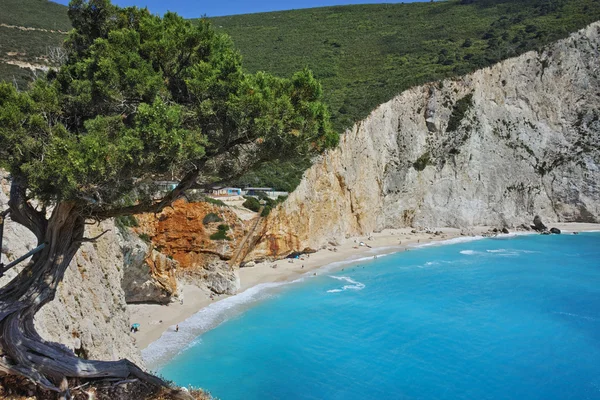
0;0;600;189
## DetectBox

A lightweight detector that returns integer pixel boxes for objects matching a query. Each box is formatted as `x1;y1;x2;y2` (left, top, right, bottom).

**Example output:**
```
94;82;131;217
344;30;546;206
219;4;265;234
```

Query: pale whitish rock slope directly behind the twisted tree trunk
0;170;142;364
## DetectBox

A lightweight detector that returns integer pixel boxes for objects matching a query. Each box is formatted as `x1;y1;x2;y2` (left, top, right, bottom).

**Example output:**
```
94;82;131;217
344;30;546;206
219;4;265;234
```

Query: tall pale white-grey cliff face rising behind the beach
253;23;600;257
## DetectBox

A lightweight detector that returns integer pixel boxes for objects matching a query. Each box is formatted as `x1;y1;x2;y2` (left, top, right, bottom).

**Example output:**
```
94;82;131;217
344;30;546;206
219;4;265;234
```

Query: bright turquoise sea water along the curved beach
159;233;600;400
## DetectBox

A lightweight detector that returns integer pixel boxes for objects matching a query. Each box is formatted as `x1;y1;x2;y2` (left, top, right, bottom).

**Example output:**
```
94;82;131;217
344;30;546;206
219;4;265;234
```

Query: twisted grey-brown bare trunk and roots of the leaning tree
0;195;165;392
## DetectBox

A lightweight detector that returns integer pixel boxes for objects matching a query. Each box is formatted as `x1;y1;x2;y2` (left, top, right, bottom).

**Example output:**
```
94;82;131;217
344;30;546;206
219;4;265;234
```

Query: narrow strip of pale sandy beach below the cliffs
128;223;600;349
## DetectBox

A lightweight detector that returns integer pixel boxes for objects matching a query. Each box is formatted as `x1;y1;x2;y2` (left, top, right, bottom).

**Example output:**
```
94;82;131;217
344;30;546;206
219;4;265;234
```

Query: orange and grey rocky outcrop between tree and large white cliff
122;200;246;303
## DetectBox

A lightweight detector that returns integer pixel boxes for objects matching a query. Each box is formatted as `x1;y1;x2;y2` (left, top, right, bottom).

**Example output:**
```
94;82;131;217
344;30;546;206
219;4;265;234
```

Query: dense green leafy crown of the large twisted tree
0;0;337;209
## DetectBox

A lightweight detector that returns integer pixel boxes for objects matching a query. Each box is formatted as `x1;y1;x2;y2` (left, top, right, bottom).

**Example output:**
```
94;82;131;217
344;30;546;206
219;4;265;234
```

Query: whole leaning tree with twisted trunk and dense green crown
0;0;337;391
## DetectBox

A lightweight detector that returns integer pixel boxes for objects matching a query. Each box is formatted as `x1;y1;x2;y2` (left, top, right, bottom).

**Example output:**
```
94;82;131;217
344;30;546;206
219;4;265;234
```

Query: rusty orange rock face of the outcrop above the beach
135;200;245;270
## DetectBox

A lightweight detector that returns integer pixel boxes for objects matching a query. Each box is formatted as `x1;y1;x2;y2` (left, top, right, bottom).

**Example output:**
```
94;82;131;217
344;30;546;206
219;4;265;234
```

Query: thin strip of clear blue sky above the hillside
54;0;422;18
